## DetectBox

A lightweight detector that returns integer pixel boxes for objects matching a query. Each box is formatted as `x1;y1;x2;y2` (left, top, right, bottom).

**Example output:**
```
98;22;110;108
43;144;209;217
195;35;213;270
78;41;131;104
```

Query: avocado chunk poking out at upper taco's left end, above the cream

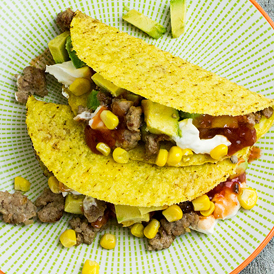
48;31;69;64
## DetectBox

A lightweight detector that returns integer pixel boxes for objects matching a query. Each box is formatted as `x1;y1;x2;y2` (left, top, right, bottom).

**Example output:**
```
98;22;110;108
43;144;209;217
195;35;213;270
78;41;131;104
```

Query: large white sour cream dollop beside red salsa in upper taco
172;119;231;154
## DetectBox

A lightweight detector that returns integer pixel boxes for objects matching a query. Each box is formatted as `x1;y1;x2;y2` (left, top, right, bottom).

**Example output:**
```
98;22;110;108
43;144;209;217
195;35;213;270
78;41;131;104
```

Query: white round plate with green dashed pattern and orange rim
0;0;274;274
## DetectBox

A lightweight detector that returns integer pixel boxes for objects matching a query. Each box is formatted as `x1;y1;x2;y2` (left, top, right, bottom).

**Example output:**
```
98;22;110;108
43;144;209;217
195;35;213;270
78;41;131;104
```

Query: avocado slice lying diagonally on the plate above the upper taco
122;9;166;39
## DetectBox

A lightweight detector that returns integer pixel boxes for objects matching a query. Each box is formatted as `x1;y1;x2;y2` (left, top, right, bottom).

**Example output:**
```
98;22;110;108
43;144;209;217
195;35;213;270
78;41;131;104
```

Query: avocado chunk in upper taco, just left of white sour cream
142;100;179;136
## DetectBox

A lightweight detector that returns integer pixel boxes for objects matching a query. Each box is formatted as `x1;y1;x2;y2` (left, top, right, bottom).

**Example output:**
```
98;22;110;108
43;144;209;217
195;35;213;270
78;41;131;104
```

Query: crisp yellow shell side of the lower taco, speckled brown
26;97;244;207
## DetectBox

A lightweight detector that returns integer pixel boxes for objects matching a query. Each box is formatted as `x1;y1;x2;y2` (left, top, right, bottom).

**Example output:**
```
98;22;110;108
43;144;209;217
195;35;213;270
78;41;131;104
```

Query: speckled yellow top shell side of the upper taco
70;11;274;116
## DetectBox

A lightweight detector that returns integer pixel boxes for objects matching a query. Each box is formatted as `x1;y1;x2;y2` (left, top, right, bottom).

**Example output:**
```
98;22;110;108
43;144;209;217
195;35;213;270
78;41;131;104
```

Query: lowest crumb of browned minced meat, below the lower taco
148;227;175;251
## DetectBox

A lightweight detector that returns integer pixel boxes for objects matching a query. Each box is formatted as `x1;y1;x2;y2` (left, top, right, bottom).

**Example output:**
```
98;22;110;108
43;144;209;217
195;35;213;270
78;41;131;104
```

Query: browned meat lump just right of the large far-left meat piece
35;188;65;223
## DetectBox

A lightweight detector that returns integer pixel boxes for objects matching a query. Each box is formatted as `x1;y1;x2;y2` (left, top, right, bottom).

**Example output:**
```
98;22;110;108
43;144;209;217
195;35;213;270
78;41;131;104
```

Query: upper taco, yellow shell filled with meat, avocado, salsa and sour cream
46;12;274;169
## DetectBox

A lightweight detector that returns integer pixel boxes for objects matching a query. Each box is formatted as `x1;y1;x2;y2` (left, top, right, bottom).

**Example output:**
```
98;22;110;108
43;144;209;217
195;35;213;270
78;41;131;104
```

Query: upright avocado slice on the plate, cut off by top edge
170;0;186;38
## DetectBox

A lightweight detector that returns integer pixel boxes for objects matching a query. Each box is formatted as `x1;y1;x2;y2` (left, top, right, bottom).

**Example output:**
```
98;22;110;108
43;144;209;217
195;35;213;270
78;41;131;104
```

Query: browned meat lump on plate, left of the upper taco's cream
15;66;48;104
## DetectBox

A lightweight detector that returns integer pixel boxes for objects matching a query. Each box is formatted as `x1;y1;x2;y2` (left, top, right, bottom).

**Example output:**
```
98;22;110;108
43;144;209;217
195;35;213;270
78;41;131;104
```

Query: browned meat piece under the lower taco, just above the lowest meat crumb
160;212;199;236
